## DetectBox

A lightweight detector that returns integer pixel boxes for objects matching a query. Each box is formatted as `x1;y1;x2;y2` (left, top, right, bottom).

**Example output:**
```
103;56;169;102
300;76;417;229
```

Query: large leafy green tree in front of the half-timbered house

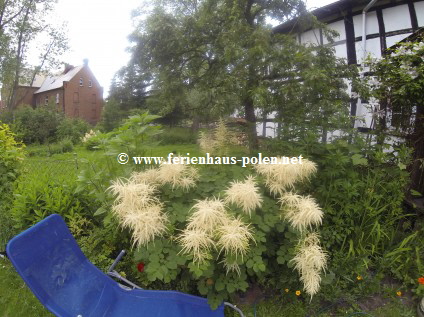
112;0;354;149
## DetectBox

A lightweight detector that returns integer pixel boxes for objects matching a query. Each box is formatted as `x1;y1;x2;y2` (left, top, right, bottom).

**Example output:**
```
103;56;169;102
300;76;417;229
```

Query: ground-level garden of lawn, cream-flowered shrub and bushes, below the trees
0;103;424;316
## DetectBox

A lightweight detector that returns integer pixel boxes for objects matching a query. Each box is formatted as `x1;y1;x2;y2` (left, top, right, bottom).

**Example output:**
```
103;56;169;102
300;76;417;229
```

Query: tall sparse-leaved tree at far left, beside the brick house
0;0;67;110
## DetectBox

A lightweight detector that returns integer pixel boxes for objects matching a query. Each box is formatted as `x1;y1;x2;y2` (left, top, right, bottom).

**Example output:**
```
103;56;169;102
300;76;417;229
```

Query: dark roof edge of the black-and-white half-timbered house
274;0;388;33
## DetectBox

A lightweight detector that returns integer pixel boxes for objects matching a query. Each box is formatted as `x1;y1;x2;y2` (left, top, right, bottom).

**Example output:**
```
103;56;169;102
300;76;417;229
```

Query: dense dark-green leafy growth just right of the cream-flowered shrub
268;136;424;297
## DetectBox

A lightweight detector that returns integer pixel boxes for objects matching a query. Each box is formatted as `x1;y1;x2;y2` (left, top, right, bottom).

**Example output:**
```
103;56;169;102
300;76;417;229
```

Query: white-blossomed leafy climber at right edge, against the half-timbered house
370;39;424;195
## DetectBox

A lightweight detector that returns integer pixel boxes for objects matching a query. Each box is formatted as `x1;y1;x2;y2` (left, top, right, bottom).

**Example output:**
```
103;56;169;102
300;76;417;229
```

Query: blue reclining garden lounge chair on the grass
6;214;242;317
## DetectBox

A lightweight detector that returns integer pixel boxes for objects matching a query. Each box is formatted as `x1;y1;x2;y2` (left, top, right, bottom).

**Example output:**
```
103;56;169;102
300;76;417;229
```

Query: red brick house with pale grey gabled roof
32;60;103;124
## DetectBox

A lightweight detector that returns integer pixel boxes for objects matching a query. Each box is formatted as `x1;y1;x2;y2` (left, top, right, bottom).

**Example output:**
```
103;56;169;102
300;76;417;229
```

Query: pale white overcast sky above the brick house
47;0;335;97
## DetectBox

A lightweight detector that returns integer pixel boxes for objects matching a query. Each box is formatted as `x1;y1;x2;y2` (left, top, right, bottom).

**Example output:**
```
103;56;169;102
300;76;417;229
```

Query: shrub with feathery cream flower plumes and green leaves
110;160;327;307
